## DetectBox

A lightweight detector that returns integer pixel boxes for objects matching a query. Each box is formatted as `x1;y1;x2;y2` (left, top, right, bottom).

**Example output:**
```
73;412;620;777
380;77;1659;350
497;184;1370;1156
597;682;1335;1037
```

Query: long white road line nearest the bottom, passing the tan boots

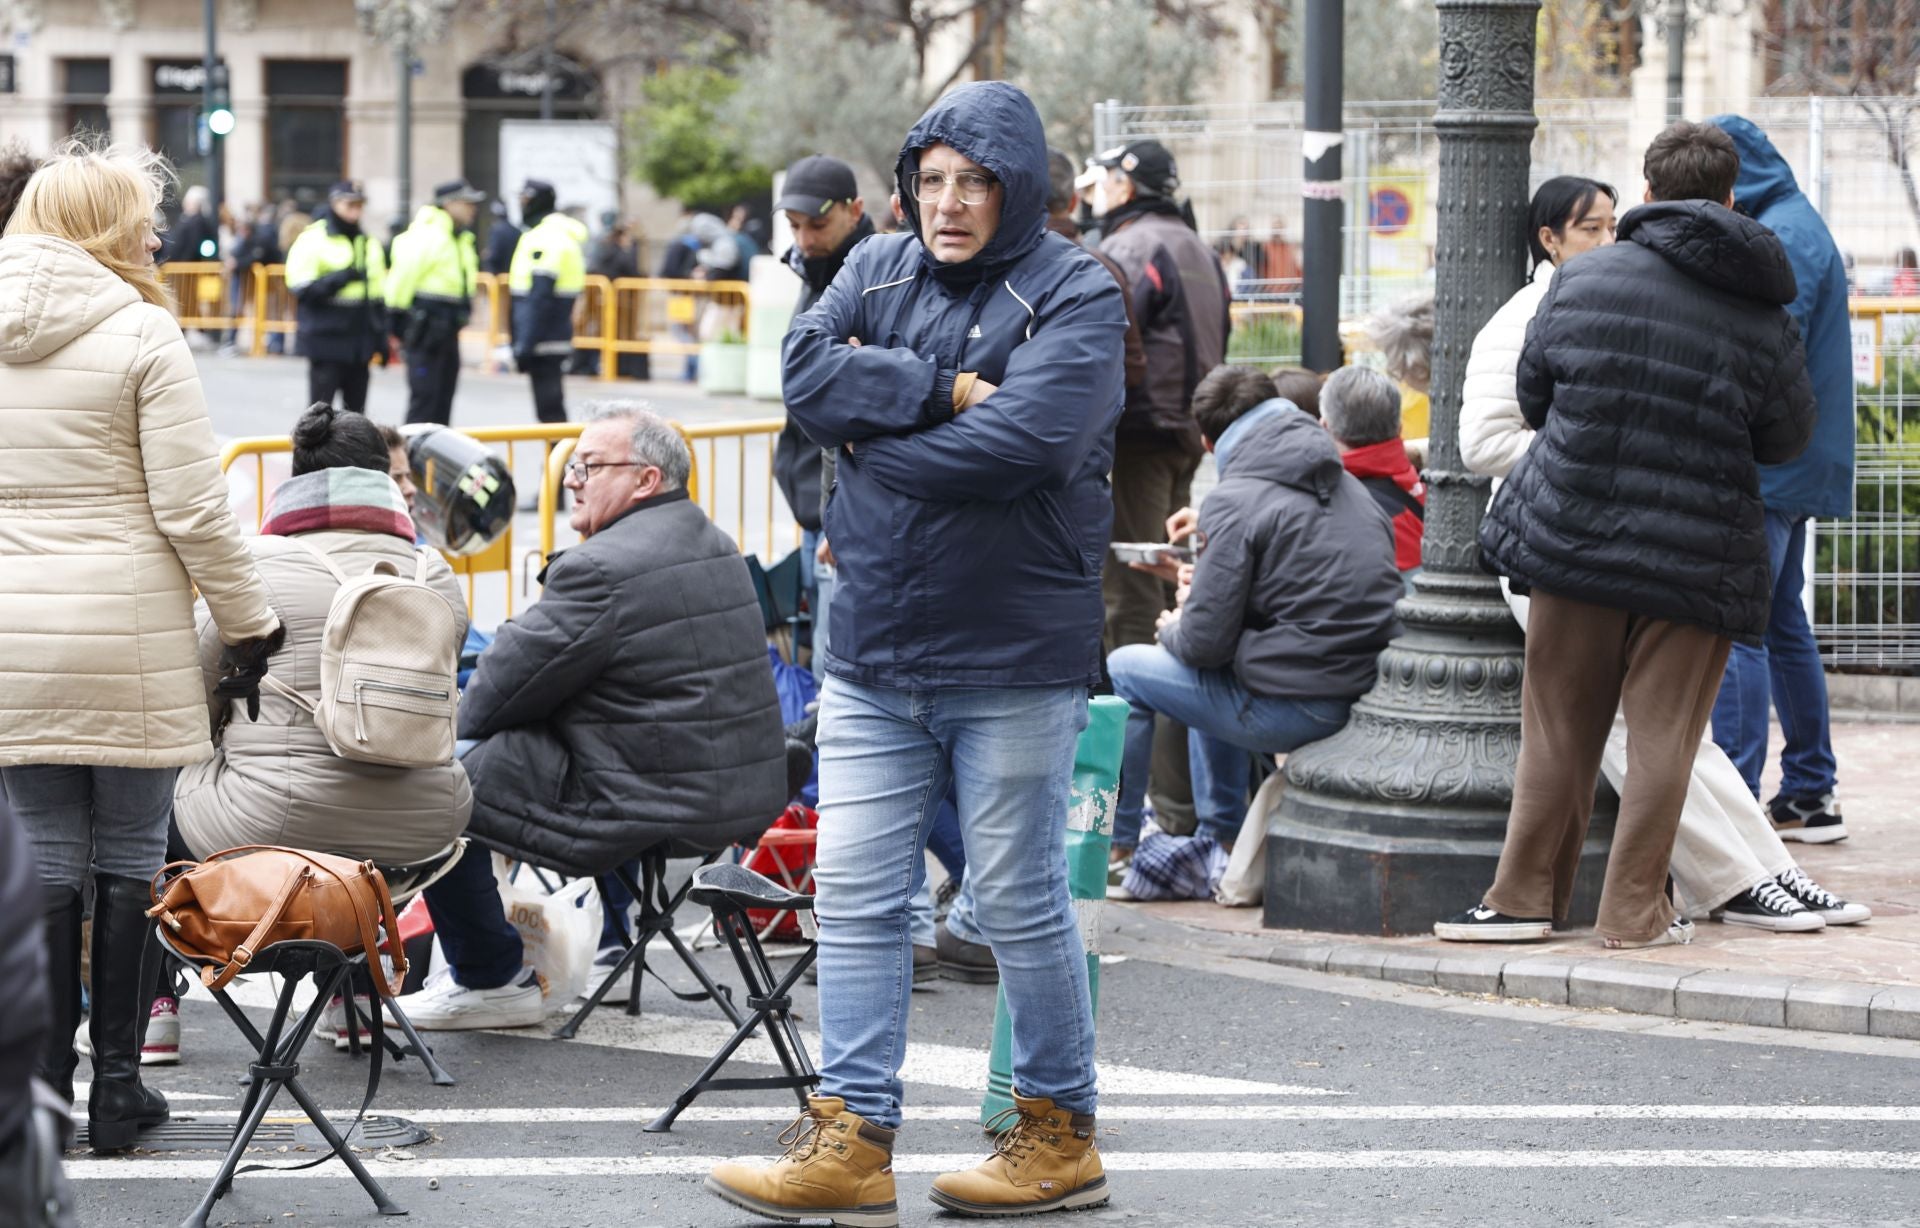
65;1147;1920;1186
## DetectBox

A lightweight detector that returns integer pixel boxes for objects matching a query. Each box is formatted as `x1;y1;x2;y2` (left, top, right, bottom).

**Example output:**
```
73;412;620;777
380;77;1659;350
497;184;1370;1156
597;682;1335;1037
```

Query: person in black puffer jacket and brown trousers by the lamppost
1436;123;1814;946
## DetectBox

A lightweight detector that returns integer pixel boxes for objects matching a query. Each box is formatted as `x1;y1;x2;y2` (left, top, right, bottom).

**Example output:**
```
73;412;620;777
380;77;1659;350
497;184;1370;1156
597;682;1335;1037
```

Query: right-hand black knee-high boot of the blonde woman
86;875;167;1151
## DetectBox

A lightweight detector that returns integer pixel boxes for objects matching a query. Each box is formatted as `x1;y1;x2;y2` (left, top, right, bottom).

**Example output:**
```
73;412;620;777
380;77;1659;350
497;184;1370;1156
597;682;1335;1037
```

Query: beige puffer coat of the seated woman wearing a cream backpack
173;530;472;865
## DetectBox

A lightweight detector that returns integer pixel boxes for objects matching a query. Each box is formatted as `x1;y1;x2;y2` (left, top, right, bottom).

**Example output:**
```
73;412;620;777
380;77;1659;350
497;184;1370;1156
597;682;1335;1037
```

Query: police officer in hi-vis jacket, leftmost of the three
286;178;386;414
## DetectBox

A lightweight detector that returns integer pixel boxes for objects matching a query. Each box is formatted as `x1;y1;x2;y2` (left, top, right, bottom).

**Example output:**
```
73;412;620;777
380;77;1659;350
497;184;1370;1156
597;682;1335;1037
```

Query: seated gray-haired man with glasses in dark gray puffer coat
405;403;787;1030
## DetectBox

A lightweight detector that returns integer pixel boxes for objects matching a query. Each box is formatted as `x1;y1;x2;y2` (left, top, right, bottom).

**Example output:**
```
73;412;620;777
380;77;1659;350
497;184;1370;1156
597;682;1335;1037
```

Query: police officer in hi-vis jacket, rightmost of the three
507;178;588;422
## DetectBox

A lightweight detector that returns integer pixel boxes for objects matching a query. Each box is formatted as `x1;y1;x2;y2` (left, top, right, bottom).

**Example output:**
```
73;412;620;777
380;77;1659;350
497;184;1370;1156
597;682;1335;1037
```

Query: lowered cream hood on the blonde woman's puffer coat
0;234;140;363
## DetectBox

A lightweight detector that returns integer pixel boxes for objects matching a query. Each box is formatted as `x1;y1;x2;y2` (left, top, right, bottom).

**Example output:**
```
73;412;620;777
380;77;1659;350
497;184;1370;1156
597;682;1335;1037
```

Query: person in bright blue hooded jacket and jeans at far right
1709;115;1855;844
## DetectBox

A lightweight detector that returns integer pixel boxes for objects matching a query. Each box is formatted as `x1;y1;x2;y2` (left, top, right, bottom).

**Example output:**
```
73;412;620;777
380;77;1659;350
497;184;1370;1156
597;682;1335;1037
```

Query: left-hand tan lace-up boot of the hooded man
707;1096;900;1228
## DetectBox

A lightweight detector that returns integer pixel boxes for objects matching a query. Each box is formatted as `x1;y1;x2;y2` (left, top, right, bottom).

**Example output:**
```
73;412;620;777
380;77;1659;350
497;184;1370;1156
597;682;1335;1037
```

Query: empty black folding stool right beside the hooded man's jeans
647;862;820;1134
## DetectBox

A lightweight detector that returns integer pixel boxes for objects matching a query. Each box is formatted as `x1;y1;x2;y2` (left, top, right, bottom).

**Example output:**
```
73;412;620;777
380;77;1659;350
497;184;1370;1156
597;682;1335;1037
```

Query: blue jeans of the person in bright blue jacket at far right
1713;512;1837;796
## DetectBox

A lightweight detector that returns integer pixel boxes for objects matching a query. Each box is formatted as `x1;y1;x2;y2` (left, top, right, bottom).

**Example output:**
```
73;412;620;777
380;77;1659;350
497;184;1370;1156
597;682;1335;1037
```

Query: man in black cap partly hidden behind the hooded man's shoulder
774;154;874;644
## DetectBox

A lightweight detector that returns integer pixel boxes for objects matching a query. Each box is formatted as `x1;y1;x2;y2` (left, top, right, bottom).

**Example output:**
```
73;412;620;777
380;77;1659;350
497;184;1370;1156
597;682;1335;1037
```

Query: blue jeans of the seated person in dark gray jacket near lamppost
1106;645;1354;848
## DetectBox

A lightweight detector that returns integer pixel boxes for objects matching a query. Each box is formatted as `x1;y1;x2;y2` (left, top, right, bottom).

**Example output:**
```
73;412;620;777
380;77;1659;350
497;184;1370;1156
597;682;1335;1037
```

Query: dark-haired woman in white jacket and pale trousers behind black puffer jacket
1434;177;1872;938
